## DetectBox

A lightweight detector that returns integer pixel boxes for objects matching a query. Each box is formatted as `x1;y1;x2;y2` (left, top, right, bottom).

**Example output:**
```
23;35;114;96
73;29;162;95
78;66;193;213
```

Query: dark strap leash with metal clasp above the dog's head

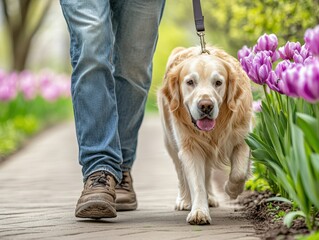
193;0;209;54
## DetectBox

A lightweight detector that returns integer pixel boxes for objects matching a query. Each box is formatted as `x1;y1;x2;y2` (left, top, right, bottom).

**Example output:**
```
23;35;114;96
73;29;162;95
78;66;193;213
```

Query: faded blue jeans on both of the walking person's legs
60;0;165;182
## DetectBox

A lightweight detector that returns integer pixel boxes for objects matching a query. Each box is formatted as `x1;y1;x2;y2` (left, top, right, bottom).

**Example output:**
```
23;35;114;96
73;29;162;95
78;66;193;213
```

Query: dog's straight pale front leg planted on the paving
179;151;211;224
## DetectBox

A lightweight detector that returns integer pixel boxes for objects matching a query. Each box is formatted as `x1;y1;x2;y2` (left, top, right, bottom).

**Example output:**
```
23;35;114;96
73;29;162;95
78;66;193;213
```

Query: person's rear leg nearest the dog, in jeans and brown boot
111;0;165;210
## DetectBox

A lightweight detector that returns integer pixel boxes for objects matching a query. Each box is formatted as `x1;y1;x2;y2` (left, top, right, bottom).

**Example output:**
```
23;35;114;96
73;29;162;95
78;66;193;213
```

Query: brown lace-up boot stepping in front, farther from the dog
75;171;116;218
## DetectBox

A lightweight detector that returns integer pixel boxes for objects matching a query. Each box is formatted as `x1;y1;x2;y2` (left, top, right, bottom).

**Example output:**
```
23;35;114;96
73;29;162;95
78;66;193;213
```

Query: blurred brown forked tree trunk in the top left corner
0;0;52;71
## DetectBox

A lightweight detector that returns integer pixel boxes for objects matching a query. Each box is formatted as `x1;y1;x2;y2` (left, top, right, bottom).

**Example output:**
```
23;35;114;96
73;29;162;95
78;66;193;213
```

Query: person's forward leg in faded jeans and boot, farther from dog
61;0;122;218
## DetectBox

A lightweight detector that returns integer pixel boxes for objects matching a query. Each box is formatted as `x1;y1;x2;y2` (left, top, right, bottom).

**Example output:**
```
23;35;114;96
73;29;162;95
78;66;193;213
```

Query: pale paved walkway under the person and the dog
0;116;258;240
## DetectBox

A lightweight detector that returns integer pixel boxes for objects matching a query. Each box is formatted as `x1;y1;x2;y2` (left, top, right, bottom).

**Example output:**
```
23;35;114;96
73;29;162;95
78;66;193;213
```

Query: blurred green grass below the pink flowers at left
0;96;72;160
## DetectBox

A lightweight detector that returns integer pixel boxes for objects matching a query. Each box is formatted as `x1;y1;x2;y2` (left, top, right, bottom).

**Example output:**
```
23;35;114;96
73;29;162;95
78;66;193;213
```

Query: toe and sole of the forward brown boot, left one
75;201;117;219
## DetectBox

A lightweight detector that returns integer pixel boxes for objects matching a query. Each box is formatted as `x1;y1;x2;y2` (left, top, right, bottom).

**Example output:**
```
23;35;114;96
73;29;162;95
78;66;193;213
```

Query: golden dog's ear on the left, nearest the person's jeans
161;67;181;112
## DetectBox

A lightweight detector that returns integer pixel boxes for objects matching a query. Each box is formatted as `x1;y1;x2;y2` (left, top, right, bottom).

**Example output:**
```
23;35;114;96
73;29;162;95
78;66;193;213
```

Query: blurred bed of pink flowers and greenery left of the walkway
0;70;71;160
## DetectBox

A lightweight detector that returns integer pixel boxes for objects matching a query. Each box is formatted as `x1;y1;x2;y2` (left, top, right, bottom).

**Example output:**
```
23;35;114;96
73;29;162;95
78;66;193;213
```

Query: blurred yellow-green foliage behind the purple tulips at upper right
202;0;319;53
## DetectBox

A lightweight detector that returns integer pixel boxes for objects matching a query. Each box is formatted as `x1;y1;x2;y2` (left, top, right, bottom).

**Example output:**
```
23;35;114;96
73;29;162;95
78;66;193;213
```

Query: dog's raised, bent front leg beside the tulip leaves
225;143;250;199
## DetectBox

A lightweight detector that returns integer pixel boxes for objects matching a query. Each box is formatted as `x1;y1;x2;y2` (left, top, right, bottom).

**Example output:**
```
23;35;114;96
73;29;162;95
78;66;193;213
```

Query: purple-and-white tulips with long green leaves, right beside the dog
238;26;319;236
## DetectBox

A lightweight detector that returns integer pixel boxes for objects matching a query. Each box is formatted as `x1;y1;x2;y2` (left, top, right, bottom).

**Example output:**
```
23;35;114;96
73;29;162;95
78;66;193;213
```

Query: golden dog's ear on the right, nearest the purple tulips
227;60;247;112
